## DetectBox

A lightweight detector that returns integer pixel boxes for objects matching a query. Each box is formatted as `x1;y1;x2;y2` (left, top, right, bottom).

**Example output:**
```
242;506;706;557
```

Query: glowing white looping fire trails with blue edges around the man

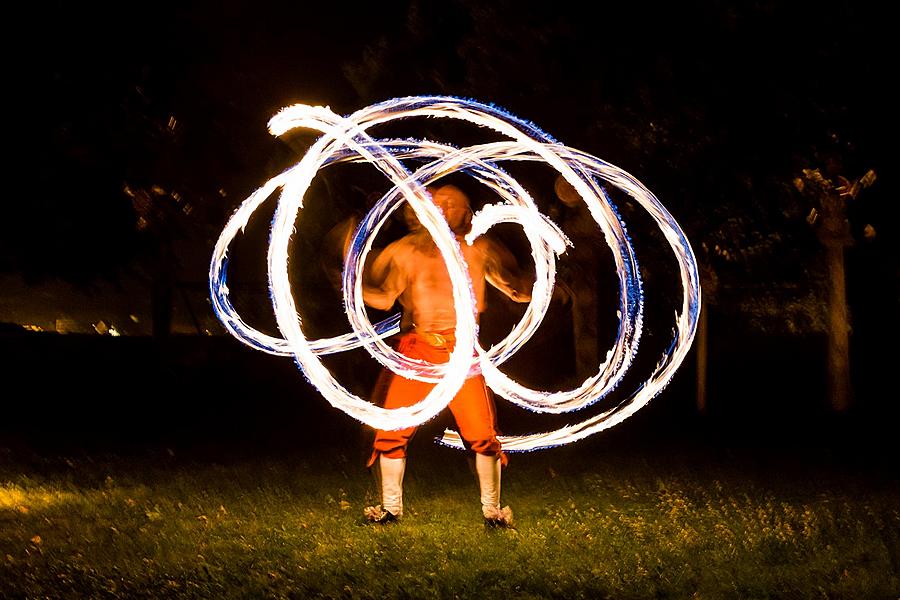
210;97;700;451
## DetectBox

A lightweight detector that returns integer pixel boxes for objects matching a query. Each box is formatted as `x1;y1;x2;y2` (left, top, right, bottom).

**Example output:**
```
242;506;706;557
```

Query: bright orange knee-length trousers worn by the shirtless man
367;330;507;467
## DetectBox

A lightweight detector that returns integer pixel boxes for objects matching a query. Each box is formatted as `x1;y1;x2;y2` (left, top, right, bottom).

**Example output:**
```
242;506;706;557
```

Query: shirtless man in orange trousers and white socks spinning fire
363;185;533;527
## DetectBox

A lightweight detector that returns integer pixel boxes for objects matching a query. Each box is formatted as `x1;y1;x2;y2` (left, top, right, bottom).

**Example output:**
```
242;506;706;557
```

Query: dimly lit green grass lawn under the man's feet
0;436;900;598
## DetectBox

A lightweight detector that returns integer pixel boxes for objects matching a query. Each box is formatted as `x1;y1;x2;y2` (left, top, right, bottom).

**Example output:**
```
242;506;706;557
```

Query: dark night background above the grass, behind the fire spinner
0;0;900;464
